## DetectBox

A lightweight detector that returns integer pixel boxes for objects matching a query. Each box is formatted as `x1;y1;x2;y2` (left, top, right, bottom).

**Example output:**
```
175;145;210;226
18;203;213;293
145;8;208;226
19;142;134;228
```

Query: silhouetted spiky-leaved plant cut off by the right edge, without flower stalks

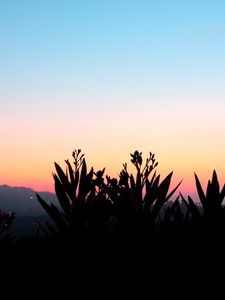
171;170;225;248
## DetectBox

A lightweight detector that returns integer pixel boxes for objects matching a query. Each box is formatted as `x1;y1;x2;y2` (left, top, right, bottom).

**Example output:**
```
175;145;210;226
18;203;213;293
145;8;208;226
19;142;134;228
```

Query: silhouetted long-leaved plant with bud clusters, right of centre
110;150;181;244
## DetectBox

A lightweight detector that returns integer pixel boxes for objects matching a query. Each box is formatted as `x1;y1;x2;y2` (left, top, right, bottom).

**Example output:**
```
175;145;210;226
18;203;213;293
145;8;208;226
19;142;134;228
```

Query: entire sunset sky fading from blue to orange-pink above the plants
0;0;225;193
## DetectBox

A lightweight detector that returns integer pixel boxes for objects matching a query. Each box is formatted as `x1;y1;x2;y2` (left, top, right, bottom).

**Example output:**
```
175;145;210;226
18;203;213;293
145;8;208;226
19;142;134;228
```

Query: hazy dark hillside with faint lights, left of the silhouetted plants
0;185;58;236
